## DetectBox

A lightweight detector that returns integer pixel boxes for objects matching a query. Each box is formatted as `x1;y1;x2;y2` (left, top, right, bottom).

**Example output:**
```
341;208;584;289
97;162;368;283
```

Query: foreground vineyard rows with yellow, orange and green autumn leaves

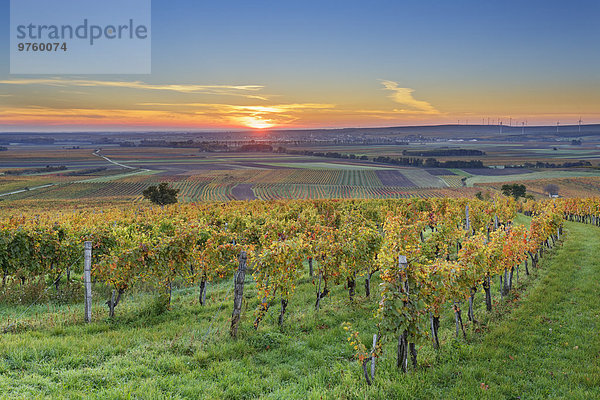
0;197;600;396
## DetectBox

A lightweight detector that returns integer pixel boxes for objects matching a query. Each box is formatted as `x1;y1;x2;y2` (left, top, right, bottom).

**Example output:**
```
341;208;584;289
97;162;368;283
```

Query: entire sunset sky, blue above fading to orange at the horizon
0;0;600;132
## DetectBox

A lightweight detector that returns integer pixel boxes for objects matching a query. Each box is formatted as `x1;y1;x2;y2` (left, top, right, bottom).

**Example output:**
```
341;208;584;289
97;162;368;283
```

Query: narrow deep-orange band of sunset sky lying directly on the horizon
0;105;599;131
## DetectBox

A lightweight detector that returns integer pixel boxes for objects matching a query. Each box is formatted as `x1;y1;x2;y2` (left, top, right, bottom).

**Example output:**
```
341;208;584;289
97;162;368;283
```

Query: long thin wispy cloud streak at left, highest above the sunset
0;78;267;100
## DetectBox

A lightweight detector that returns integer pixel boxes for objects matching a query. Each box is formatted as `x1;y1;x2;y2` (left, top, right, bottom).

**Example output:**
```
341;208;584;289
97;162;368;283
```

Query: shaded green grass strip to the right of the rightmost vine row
412;219;600;398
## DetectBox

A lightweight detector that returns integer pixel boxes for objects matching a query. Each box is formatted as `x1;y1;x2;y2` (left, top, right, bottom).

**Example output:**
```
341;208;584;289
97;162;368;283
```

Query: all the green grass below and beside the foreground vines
0;218;600;399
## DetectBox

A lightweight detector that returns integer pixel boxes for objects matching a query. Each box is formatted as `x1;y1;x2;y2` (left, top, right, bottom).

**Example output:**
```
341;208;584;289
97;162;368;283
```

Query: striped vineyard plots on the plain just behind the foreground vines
7;156;600;203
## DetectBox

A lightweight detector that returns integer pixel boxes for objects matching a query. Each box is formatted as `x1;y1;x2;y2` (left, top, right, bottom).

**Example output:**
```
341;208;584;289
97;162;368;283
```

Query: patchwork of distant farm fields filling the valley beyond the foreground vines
0;142;600;202
